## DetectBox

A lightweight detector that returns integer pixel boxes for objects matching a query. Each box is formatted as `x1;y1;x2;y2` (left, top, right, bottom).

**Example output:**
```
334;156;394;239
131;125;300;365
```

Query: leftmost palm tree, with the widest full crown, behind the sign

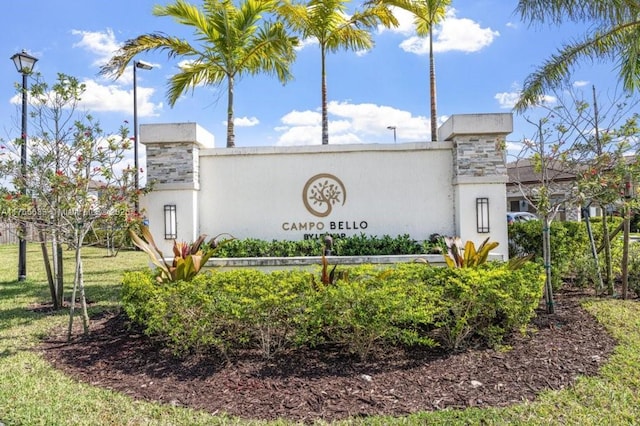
101;0;297;147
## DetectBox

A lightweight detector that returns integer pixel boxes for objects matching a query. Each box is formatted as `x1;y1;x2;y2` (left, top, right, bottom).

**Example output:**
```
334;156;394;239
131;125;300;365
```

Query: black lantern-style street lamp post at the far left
11;50;38;281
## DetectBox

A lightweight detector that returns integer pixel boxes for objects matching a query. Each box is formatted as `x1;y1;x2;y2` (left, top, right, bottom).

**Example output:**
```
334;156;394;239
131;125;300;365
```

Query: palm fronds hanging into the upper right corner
515;0;640;111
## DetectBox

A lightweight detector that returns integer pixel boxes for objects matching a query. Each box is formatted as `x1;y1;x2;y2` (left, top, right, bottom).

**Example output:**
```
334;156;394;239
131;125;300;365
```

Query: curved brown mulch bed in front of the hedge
40;291;615;422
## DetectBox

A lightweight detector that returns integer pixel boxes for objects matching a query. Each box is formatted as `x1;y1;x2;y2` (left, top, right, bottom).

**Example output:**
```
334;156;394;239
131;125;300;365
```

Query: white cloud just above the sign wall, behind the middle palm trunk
275;101;429;146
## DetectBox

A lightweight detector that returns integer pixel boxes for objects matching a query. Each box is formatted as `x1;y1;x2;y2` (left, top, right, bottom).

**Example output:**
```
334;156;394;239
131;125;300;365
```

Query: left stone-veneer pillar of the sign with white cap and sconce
140;123;214;255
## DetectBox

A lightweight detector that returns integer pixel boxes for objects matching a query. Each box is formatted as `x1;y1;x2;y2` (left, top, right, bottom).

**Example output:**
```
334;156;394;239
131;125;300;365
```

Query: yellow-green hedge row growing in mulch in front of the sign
122;263;544;358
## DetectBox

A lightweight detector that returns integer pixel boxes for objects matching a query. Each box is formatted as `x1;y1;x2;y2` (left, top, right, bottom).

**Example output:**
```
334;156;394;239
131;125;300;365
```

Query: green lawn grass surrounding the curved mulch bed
0;245;640;426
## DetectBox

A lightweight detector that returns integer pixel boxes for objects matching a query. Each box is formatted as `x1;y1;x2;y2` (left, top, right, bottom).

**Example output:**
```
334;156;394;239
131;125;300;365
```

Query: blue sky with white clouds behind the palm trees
0;0;616;164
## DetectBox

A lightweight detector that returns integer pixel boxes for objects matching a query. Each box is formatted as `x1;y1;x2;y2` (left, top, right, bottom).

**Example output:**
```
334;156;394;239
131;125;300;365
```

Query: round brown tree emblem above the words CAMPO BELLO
302;173;347;217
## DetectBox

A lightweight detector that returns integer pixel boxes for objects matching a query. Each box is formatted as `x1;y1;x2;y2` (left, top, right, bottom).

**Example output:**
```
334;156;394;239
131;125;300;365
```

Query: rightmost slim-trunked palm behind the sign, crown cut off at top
373;0;451;142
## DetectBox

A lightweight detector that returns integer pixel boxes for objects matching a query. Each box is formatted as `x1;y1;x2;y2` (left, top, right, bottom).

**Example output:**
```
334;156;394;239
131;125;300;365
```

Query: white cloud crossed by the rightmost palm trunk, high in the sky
400;8;500;55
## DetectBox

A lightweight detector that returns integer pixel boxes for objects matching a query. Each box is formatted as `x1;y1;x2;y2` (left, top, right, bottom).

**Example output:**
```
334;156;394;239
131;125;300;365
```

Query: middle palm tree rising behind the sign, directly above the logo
278;0;398;145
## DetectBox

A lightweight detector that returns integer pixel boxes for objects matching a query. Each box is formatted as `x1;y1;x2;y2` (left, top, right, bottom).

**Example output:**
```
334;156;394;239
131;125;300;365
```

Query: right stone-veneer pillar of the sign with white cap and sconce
438;113;513;259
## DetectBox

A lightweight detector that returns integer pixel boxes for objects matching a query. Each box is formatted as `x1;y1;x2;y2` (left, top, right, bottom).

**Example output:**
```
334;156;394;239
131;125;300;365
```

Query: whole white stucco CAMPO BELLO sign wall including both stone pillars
140;114;511;257
